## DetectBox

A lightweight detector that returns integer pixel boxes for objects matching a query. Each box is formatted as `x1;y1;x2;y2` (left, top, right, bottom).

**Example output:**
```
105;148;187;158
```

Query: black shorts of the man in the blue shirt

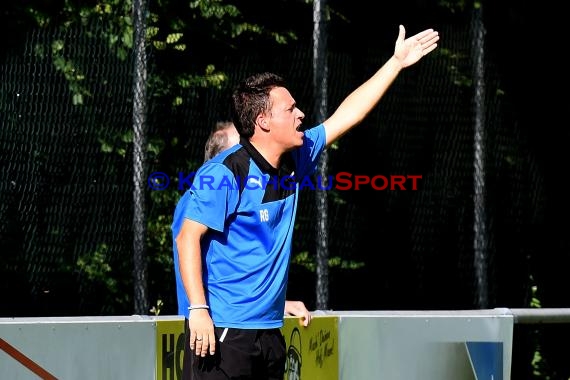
182;319;286;380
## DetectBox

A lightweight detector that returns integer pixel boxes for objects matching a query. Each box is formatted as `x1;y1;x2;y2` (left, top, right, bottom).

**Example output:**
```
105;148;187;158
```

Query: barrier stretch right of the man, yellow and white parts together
282;309;514;380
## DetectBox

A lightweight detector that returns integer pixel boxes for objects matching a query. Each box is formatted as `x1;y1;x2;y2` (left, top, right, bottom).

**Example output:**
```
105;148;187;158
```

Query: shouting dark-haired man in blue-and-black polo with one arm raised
172;26;439;380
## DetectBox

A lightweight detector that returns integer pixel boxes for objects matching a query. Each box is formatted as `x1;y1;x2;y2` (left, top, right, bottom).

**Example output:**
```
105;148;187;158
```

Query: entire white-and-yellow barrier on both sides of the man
0;309;513;380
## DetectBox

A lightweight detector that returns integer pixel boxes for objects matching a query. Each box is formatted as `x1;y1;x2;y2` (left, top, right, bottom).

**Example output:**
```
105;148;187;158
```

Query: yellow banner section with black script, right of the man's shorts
281;316;339;380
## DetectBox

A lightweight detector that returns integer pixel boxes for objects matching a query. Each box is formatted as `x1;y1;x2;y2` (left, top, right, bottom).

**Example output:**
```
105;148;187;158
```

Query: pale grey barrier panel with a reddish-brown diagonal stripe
0;316;173;380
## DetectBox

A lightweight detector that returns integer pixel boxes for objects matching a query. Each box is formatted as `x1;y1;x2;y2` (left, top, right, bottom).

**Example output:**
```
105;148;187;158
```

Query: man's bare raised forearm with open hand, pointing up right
324;25;439;145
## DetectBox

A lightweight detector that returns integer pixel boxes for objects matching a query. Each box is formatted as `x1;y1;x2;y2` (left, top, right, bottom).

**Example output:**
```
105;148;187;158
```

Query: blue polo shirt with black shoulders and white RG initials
172;124;326;329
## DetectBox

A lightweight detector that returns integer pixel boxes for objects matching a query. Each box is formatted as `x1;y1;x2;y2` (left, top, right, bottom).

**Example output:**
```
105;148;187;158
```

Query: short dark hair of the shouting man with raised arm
231;72;286;138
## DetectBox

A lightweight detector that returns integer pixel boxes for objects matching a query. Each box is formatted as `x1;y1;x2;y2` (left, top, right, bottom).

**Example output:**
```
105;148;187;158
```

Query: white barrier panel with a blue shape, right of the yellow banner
328;312;513;380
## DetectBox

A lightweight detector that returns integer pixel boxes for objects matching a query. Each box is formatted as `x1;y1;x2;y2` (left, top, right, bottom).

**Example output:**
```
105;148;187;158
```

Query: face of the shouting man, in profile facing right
267;87;305;150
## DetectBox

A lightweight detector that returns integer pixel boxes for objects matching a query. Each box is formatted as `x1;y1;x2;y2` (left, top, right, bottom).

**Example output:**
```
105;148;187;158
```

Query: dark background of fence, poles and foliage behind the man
0;0;570;379
